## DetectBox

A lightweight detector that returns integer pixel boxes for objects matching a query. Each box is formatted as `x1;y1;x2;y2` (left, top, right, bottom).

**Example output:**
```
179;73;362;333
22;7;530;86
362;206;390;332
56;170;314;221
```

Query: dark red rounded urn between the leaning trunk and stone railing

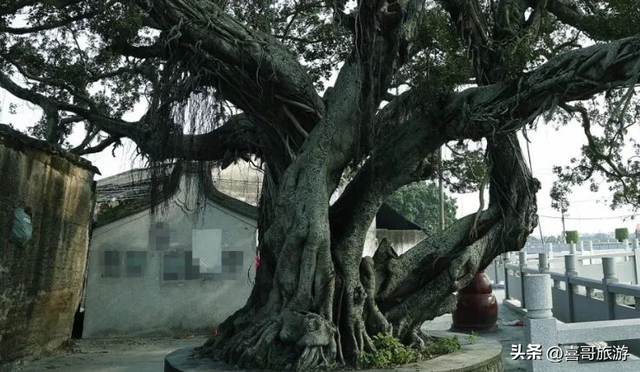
452;270;498;331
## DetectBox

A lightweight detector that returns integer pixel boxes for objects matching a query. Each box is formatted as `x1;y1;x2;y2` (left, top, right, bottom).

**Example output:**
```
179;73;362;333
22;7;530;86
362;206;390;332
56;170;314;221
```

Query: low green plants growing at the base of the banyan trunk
360;334;460;368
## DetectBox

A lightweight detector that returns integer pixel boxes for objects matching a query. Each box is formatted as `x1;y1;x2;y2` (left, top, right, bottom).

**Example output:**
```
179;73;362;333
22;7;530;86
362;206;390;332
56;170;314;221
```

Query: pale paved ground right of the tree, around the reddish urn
422;289;527;372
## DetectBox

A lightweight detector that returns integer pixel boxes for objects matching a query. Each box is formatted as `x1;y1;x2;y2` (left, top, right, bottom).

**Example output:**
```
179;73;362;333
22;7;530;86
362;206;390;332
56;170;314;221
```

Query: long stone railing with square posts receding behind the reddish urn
486;249;640;371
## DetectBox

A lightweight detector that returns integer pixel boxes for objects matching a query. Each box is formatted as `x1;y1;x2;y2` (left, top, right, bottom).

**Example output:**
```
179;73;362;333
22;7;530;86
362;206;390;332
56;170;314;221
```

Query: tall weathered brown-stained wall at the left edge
0;127;94;363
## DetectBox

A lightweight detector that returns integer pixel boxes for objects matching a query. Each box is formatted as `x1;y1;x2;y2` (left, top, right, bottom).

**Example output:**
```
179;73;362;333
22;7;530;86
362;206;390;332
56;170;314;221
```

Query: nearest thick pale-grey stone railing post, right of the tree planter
523;274;558;372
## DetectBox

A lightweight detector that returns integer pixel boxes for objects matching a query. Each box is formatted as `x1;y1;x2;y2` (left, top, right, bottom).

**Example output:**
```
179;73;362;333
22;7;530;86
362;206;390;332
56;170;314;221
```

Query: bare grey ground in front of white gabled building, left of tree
0;336;207;372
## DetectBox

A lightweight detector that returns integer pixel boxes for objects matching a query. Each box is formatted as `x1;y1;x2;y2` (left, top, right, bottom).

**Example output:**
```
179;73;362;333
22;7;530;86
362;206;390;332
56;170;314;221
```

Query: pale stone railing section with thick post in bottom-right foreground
523;274;640;372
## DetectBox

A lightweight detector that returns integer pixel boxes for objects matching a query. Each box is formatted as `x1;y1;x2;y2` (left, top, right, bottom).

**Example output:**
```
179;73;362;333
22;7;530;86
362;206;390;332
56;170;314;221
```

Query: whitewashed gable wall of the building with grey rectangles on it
83;173;256;337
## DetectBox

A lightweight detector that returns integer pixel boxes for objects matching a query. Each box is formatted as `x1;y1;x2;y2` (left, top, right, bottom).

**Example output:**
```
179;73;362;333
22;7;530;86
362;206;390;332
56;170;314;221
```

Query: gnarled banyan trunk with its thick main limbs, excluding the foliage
146;0;537;371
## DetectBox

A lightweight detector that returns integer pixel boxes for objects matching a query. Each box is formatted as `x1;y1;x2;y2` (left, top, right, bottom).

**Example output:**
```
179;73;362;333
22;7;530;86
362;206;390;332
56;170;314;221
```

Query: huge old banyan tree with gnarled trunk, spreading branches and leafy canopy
0;0;640;370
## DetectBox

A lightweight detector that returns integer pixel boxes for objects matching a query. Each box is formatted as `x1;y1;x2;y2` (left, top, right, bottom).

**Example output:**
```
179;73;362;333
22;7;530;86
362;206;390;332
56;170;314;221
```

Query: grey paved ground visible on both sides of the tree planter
5;289;526;372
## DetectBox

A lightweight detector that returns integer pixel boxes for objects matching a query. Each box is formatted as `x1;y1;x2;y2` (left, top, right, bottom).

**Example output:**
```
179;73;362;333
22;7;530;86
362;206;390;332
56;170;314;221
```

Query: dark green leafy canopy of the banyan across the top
0;0;640;215
